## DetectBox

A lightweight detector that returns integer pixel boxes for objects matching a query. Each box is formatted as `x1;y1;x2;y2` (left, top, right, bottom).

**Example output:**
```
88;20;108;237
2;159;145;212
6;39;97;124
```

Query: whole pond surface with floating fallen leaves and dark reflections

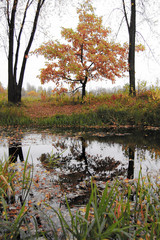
0;128;160;239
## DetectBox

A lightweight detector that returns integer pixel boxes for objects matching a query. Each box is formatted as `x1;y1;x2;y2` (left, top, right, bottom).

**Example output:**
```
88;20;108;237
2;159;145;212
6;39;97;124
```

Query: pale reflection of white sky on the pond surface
0;133;160;178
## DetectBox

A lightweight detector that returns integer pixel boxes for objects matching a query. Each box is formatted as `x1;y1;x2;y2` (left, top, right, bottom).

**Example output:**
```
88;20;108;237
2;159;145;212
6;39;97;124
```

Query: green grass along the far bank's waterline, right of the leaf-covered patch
33;104;160;128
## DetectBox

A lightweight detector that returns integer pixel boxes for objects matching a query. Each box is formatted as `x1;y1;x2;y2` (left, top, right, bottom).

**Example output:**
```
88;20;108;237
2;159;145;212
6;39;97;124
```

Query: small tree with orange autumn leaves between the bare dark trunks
34;0;127;99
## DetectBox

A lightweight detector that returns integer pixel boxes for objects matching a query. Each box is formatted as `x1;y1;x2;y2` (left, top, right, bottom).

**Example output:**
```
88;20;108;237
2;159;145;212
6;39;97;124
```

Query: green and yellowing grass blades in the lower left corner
0;151;33;240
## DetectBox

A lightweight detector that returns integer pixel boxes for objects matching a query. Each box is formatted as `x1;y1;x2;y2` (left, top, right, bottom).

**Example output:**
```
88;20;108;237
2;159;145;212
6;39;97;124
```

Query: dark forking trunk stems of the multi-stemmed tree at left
7;0;45;103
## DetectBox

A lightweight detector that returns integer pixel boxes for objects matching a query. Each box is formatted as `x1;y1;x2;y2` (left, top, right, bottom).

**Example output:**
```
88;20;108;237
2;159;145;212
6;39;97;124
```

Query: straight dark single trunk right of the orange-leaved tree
128;0;136;96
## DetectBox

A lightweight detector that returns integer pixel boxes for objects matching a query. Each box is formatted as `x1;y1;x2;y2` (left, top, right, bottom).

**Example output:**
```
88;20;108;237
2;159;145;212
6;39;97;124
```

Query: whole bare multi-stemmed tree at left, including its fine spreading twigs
0;0;82;103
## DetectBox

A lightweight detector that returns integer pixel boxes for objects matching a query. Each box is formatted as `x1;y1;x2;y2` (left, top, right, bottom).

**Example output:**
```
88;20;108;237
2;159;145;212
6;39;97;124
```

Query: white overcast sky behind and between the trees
0;0;160;91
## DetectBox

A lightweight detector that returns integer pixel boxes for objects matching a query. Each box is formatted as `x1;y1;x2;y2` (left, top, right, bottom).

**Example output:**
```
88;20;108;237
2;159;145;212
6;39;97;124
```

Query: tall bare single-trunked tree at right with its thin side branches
122;0;159;96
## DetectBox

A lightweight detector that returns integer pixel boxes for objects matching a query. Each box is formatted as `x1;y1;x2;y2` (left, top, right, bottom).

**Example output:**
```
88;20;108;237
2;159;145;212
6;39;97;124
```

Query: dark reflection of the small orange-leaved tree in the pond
39;137;127;204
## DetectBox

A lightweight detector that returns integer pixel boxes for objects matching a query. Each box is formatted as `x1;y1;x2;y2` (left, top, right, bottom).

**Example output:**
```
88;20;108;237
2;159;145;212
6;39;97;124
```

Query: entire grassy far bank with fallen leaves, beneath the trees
0;89;160;128
